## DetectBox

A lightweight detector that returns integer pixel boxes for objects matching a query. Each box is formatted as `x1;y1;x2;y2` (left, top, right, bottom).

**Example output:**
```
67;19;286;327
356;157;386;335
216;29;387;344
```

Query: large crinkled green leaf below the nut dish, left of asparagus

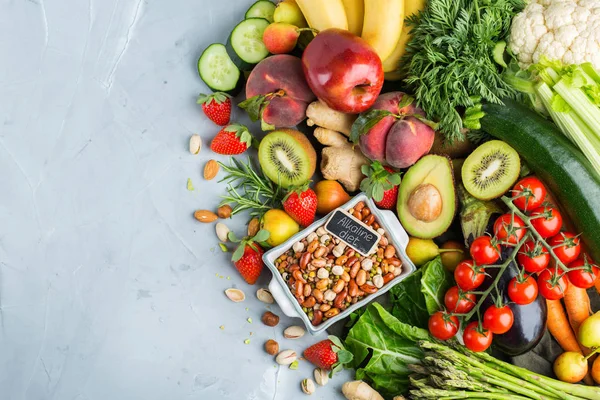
345;303;429;397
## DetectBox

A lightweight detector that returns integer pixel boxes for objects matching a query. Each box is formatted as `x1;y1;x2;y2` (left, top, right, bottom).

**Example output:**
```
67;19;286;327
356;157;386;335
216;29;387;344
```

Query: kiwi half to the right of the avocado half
461;140;521;200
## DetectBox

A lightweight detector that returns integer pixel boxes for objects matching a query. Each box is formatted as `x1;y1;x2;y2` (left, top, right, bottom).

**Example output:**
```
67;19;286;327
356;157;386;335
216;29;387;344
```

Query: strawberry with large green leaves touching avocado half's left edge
360;161;400;210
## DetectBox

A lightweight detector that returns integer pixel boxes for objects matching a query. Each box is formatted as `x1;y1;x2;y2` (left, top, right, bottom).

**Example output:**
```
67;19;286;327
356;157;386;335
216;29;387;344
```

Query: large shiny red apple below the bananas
302;28;383;114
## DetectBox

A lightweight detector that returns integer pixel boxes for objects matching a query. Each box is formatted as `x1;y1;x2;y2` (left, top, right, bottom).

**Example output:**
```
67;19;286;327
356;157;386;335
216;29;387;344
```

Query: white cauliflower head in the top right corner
509;0;600;69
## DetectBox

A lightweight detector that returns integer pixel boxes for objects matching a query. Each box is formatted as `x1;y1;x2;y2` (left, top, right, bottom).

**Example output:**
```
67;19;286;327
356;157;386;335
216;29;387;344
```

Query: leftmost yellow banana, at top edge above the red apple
296;0;348;31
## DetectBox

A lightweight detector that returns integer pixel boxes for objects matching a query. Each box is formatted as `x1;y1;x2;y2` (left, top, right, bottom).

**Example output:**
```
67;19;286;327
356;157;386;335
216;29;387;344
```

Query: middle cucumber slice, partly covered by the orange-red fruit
227;18;269;71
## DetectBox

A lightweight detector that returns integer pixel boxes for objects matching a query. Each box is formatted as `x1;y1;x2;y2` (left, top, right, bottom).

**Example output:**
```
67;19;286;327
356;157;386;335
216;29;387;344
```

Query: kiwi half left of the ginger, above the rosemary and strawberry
258;129;317;188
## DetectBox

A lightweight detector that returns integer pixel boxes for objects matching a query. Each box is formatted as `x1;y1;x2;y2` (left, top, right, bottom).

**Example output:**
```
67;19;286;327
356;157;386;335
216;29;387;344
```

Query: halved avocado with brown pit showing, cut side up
397;154;456;239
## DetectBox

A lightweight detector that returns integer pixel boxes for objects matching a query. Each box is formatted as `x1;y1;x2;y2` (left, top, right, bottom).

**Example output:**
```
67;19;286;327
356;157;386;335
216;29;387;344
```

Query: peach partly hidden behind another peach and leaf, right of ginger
359;92;424;162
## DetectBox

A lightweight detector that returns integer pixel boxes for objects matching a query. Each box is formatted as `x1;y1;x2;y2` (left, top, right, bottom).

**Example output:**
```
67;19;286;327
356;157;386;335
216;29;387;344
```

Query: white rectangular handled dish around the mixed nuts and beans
263;193;416;335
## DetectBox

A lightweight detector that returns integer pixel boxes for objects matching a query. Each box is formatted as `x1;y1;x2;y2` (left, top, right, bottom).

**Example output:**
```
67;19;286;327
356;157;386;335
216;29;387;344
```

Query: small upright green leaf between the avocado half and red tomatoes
421;256;452;315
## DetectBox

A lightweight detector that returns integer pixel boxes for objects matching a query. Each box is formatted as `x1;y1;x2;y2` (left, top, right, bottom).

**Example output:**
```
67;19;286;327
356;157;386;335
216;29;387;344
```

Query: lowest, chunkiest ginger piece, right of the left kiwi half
321;144;370;192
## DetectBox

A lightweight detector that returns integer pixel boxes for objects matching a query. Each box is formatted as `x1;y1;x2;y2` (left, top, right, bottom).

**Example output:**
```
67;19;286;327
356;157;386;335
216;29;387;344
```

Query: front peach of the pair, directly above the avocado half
385;117;435;168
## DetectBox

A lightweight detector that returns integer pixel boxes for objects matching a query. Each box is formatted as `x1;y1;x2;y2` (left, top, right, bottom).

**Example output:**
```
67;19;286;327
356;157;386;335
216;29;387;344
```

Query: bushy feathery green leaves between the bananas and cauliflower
403;0;524;143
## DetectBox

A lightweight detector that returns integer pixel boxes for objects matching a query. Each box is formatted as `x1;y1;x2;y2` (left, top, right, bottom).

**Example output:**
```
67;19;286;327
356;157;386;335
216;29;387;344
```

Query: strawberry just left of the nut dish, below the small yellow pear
229;229;269;285
